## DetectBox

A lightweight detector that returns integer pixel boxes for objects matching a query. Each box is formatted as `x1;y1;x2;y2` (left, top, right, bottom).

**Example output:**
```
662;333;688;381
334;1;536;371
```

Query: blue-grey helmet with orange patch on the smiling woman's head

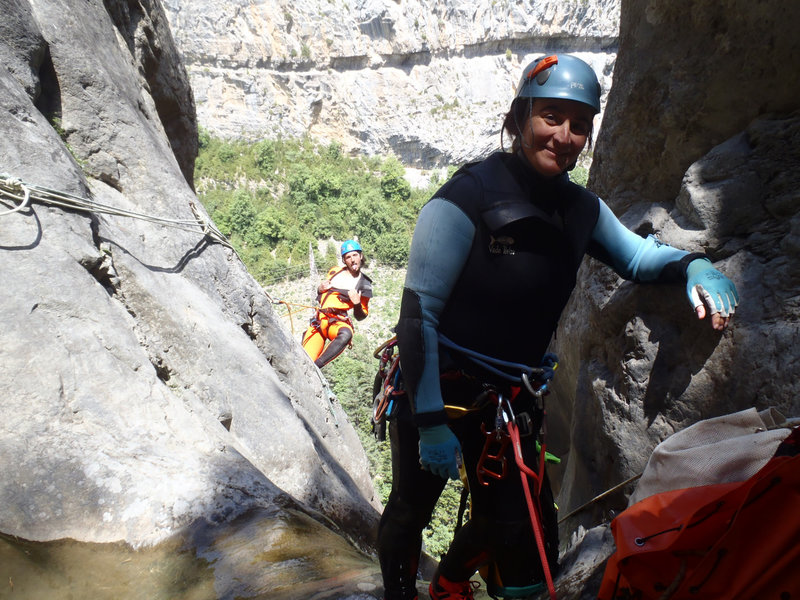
515;54;600;114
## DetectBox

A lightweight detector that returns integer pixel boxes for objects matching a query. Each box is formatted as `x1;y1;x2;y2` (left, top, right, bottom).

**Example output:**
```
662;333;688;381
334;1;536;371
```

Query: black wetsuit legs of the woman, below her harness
378;390;558;600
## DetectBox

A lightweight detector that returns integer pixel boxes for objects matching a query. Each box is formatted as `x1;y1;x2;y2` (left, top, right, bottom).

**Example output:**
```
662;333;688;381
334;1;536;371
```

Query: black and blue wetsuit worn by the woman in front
379;153;702;600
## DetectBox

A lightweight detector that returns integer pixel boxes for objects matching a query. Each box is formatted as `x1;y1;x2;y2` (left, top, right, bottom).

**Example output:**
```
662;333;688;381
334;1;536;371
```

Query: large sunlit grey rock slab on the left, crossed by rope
0;0;378;547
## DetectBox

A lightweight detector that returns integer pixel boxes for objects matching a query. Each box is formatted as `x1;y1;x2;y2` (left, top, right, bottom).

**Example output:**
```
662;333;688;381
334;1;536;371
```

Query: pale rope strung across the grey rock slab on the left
0;174;233;250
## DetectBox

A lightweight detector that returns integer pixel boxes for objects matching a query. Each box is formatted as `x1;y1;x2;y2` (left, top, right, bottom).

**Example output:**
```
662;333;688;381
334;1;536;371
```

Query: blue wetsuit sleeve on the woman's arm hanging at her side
397;198;475;426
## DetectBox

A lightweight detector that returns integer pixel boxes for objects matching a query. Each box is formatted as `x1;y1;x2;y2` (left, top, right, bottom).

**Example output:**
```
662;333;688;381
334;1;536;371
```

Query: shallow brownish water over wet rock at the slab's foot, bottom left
0;511;381;600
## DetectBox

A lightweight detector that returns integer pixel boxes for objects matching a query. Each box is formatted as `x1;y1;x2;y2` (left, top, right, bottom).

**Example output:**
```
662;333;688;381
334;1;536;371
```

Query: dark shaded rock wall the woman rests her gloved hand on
551;1;800;540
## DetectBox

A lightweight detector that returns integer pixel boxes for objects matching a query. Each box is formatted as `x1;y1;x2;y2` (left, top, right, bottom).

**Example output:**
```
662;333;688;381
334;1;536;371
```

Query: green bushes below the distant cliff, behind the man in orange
195;130;432;284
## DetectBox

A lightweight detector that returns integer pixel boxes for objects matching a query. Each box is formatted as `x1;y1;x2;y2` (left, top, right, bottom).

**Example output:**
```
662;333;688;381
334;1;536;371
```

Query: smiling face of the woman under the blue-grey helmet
522;98;594;177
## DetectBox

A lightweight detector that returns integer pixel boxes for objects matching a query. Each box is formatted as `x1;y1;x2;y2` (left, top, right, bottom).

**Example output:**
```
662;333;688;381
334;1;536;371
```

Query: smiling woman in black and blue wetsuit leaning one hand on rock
378;54;738;600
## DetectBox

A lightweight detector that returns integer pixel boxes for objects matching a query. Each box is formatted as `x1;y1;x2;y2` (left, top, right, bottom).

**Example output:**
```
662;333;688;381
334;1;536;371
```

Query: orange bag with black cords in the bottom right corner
598;428;800;600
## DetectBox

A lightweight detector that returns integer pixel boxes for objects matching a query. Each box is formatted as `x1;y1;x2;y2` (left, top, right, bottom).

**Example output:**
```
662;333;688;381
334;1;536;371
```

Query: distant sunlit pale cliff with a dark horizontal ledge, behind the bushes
164;0;620;168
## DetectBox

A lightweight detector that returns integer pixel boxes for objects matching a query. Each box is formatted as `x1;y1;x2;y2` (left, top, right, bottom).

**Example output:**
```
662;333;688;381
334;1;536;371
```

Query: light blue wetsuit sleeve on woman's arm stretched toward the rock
590;199;705;282
